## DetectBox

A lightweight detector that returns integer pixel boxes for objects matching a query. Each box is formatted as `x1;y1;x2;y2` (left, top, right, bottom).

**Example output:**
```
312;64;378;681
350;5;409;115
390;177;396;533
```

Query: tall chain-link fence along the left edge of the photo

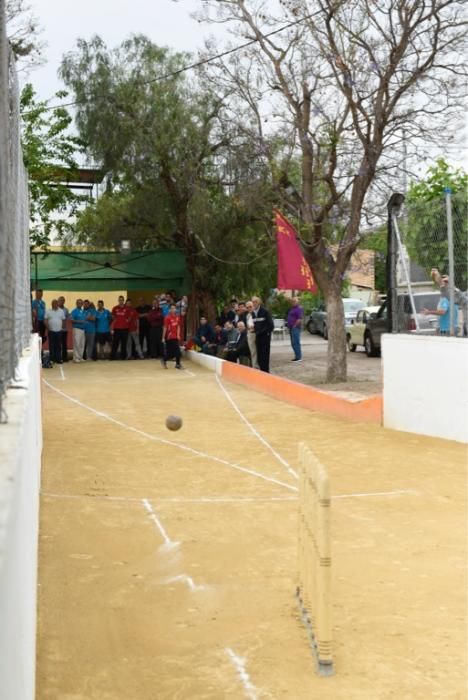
0;5;31;419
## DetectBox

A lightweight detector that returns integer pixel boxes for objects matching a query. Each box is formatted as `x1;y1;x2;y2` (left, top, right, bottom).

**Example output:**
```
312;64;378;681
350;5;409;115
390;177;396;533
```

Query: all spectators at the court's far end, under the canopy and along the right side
32;289;303;372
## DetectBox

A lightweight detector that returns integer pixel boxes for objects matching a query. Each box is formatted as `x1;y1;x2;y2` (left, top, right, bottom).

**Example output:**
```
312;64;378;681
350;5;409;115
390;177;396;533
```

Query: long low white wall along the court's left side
0;336;42;700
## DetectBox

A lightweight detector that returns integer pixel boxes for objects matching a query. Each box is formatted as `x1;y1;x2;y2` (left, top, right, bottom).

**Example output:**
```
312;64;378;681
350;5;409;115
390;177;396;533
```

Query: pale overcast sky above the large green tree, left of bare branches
28;0;227;99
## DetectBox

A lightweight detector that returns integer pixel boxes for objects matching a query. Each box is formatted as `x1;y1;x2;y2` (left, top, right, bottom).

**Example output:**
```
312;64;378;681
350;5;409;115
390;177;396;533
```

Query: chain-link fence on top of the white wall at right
389;190;468;336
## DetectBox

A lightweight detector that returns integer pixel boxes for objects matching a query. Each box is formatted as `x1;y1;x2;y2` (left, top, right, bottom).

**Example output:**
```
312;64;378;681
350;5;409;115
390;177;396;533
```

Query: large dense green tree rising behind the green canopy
61;36;273;322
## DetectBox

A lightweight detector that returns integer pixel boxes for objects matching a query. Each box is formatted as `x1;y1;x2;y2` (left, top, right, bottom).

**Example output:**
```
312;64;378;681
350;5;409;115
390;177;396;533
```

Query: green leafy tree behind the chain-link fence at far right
405;159;468;289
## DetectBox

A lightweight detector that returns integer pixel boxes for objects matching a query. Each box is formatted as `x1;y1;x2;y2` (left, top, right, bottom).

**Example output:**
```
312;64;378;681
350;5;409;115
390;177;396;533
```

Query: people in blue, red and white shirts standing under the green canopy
32;289;187;369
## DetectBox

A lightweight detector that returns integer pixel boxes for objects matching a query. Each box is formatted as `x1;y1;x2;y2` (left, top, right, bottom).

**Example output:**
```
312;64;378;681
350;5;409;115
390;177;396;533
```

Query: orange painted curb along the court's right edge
222;362;383;425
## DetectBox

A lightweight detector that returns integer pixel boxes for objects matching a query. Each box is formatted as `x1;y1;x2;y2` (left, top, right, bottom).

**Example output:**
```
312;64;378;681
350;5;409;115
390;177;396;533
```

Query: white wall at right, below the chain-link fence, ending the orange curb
382;334;468;443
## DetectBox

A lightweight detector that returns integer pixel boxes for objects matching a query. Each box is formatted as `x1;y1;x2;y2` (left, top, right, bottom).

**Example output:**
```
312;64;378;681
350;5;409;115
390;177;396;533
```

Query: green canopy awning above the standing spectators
31;250;190;294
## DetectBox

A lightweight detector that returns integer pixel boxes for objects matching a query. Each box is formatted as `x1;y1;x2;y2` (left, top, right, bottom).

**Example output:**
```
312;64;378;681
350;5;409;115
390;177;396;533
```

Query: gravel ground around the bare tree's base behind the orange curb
270;331;382;396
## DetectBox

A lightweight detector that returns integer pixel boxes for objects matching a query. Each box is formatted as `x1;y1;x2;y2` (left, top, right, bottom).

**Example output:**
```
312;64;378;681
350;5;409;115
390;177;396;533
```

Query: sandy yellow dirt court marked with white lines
37;360;467;700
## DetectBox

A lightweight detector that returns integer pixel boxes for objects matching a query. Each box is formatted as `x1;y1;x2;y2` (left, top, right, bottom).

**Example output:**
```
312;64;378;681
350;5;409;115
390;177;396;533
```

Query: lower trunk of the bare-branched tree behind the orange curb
326;282;347;383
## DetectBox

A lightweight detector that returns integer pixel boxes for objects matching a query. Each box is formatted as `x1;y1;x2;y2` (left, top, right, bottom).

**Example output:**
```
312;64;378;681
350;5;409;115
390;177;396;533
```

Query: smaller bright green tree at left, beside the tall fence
20;84;82;247
